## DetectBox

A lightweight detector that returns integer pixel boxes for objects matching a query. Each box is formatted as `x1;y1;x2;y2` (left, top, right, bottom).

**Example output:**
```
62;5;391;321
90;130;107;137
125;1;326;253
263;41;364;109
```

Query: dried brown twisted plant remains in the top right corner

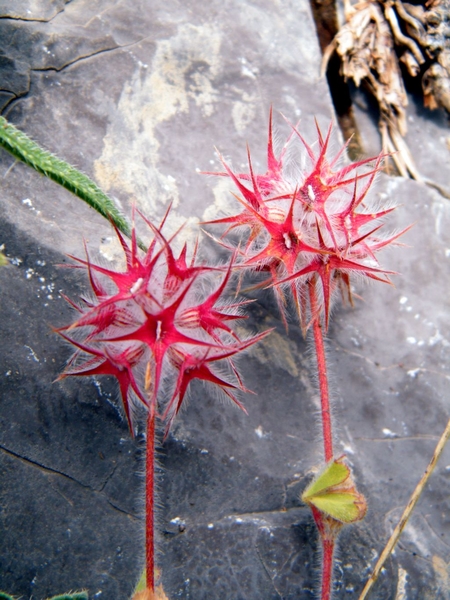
323;0;450;180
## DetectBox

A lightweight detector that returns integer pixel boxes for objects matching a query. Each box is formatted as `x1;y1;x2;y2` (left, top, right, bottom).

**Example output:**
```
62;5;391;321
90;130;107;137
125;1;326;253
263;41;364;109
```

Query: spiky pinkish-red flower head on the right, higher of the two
204;111;403;330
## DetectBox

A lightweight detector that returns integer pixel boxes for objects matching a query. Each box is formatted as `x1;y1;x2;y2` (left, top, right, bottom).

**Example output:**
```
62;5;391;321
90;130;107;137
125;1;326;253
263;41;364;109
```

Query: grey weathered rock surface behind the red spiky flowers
0;0;450;600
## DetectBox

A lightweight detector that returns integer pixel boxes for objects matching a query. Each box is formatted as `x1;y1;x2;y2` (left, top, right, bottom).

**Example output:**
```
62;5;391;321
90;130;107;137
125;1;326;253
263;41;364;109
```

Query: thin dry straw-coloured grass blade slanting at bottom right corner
359;420;450;600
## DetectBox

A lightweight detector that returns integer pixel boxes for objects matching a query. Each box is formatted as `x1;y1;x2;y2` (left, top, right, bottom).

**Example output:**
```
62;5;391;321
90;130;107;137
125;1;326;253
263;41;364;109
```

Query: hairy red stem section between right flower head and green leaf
309;283;333;462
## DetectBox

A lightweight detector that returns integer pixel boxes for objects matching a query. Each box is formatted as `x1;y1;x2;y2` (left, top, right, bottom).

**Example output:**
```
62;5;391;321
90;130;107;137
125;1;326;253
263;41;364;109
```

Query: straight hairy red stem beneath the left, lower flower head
145;407;155;592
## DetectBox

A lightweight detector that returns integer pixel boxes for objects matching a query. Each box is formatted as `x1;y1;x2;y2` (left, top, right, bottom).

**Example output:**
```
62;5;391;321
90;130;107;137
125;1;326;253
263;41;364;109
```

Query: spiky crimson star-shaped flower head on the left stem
58;215;266;433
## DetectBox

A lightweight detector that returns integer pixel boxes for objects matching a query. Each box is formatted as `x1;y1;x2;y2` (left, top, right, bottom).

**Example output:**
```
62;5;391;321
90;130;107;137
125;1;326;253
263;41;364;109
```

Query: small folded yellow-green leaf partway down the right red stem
302;458;367;523
